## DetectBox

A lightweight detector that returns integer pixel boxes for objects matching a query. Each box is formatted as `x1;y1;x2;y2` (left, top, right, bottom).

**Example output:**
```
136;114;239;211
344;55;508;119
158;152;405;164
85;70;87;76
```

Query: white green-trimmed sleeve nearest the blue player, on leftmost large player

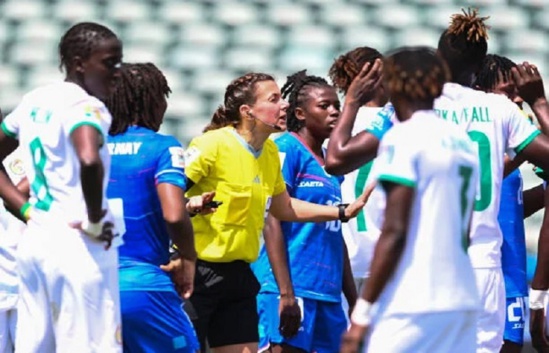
62;101;112;138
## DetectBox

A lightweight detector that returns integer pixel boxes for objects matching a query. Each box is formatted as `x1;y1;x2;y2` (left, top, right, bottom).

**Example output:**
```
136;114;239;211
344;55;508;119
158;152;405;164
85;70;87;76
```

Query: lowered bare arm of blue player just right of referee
263;215;301;338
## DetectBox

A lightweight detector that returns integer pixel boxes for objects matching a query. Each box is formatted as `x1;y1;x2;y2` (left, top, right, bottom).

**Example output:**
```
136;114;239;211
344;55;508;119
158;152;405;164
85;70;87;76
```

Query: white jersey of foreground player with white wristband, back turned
376;111;479;315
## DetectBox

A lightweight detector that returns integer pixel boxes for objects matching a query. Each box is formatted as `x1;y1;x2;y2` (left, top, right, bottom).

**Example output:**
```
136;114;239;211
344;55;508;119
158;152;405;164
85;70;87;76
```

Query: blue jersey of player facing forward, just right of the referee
254;133;343;302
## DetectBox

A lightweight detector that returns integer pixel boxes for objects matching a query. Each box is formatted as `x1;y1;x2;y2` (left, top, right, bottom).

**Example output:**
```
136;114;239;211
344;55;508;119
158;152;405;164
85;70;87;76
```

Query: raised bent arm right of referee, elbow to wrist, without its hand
325;101;379;175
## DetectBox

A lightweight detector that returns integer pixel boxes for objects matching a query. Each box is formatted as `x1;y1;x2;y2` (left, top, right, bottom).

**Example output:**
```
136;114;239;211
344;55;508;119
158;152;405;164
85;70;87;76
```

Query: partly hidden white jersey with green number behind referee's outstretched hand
341;107;381;278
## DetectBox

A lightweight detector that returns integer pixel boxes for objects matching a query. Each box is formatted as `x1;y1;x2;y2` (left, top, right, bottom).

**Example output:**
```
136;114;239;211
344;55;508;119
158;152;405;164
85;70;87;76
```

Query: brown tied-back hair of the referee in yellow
204;72;274;132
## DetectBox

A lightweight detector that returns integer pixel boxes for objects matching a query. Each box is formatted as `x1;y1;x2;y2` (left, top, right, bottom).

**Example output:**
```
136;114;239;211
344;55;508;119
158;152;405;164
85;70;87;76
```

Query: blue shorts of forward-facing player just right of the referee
257;293;347;353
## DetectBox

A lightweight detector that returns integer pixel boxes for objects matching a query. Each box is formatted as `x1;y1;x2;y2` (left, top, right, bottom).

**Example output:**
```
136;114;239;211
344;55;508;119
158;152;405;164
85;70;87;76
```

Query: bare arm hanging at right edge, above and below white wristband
530;189;549;352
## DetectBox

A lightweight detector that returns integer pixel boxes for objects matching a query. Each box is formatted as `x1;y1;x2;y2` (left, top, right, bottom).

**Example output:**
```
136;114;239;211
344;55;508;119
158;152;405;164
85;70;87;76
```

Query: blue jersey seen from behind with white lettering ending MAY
107;126;186;291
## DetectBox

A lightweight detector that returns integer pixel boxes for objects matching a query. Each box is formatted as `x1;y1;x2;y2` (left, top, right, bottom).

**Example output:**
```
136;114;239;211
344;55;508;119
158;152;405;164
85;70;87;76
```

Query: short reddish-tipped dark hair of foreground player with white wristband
383;47;450;101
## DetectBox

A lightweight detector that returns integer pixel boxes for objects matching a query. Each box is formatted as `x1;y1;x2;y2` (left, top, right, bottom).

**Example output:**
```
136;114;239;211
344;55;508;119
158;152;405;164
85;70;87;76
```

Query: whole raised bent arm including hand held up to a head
325;59;383;175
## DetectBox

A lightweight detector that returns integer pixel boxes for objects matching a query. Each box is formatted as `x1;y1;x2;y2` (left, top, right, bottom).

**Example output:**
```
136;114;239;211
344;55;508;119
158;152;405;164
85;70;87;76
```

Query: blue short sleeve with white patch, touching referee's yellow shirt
154;139;187;190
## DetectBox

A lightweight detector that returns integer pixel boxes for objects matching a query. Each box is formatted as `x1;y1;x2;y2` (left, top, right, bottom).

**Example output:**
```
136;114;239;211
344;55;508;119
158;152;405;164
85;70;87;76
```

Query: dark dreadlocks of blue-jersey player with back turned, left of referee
105;63;171;135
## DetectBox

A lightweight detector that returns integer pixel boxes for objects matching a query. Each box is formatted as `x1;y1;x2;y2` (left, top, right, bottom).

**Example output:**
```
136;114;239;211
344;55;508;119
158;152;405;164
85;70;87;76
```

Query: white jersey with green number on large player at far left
2;82;112;224
